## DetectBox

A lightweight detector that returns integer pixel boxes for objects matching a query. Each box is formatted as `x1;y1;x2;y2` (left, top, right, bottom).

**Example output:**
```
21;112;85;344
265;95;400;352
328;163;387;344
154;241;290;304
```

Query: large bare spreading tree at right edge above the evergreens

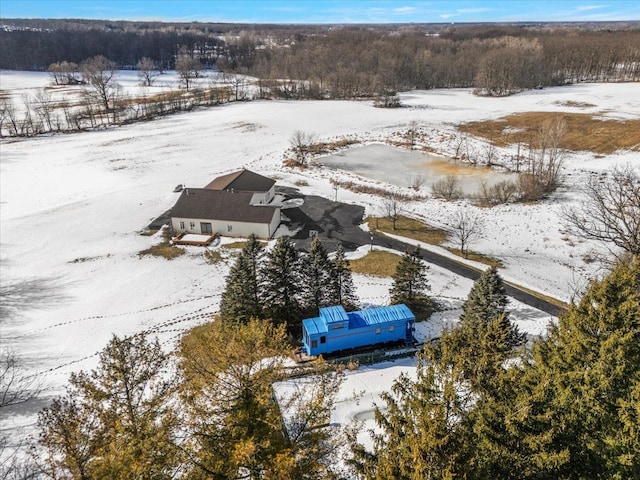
563;165;640;256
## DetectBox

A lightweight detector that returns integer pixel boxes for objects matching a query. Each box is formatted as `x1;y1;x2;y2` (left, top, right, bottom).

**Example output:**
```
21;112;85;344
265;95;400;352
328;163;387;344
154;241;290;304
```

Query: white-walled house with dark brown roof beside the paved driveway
171;170;280;238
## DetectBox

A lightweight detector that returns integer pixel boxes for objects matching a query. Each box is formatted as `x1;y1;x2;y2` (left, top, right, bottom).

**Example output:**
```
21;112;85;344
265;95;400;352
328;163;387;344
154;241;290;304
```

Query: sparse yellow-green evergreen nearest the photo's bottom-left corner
38;335;182;480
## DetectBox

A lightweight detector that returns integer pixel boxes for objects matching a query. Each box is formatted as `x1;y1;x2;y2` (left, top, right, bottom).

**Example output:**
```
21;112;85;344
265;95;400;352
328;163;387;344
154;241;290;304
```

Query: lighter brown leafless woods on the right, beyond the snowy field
245;27;640;98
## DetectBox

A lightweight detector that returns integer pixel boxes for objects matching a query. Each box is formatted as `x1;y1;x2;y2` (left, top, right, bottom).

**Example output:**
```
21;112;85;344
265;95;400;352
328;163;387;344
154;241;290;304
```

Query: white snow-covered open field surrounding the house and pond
0;72;640;450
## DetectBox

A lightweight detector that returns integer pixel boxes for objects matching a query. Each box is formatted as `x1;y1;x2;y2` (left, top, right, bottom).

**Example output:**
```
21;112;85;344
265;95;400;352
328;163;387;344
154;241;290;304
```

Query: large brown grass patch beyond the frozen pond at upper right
458;112;640;155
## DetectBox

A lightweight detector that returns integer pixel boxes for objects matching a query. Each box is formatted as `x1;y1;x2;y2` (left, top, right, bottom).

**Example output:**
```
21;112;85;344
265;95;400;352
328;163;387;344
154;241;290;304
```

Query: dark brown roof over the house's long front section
171;188;278;223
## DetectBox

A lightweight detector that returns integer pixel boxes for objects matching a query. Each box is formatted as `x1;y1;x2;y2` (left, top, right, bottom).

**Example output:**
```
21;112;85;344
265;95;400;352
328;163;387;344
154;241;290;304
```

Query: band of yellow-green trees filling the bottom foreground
0;248;640;480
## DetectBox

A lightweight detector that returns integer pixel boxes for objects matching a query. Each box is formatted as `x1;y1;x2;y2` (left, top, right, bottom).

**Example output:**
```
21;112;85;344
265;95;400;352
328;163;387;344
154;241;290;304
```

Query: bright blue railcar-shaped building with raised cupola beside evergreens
302;304;416;355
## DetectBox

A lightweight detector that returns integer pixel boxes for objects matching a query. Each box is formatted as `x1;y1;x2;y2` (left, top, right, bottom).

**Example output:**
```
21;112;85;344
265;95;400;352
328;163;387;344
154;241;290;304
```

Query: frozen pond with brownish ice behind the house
315;144;517;195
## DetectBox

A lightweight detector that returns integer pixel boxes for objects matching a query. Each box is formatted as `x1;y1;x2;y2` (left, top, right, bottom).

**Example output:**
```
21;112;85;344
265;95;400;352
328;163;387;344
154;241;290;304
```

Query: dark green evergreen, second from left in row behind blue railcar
260;237;302;333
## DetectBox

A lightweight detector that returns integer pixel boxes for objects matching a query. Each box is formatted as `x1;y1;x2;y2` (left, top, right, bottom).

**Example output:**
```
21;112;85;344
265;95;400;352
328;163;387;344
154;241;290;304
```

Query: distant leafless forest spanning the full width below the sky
0;20;640;98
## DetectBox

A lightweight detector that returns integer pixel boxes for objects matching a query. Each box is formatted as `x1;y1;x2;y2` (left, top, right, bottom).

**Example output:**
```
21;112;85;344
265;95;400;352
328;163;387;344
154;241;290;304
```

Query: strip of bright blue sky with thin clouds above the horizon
0;0;640;23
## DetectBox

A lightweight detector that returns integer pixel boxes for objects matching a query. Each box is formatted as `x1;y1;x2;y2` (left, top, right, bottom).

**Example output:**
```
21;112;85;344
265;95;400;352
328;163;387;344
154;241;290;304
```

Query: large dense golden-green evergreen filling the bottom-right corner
517;258;640;479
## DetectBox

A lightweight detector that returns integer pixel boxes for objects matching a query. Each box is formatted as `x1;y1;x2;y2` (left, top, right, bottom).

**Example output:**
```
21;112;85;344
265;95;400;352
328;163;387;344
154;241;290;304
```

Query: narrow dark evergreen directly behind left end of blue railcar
301;236;335;316
